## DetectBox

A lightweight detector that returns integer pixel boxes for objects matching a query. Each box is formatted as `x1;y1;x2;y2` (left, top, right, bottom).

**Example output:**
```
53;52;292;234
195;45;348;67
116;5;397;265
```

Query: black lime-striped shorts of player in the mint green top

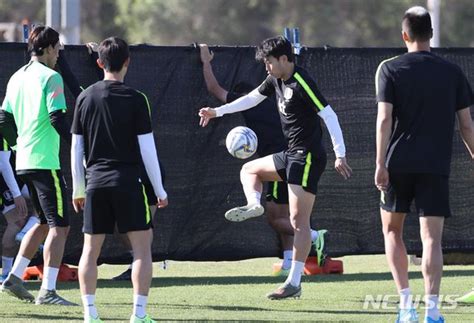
20;169;69;227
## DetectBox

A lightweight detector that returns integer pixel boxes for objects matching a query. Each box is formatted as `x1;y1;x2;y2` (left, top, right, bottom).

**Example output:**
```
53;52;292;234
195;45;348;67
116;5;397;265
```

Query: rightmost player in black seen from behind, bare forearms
375;7;474;323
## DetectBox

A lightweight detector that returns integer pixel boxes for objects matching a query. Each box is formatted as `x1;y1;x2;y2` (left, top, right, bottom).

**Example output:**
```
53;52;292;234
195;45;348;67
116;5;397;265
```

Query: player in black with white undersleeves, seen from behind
71;37;168;322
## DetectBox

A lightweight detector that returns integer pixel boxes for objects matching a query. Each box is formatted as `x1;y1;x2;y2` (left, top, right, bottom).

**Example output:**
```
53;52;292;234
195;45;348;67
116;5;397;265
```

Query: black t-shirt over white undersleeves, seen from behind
72;81;151;189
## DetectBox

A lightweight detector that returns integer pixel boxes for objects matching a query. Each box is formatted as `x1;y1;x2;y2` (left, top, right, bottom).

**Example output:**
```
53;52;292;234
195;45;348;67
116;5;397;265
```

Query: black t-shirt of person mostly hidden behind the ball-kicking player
226;91;288;157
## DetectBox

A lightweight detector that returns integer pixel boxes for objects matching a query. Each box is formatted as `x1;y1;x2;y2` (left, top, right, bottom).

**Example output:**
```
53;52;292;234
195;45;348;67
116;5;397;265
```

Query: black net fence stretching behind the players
0;44;474;264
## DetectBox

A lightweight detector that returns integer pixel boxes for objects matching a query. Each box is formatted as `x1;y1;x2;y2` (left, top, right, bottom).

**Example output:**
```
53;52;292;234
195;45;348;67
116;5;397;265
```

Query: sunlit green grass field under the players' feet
0;256;474;322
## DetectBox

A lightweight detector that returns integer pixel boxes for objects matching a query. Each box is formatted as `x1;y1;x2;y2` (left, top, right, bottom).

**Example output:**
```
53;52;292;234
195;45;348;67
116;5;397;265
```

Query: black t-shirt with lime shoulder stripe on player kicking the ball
258;66;328;152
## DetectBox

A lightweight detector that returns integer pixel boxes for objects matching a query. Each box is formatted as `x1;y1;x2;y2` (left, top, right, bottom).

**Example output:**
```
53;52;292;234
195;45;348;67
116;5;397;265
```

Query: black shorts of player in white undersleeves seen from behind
82;185;152;234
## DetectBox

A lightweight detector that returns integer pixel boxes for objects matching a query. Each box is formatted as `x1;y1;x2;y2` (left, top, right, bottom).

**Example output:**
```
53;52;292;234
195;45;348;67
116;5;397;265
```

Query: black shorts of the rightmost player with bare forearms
380;172;451;218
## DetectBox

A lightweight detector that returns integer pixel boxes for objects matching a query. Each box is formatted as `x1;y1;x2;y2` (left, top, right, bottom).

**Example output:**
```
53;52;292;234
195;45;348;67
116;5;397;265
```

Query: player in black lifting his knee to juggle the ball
199;36;352;299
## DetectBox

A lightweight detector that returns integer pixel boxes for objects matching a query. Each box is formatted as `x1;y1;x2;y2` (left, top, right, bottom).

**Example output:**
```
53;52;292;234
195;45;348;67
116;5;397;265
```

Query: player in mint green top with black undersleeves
0;26;76;305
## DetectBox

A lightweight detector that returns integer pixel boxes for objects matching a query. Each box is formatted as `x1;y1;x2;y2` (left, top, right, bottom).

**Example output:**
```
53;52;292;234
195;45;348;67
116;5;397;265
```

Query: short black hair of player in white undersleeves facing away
98;37;130;72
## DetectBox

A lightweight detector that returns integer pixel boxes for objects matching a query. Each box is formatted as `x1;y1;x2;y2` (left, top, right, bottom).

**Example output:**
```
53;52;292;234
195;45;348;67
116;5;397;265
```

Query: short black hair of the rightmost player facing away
402;6;433;41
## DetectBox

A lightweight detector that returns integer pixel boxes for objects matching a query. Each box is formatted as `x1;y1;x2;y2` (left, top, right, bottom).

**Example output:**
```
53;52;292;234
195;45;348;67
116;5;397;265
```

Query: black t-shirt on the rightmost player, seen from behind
376;51;473;175
